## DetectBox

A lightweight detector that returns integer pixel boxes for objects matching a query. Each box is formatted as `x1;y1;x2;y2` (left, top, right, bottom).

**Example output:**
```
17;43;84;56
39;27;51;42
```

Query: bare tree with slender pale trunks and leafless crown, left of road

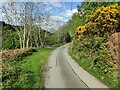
2;2;41;49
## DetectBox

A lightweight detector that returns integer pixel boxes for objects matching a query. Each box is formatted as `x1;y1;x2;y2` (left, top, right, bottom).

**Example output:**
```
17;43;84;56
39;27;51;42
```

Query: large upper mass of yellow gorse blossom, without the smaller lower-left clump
87;4;120;35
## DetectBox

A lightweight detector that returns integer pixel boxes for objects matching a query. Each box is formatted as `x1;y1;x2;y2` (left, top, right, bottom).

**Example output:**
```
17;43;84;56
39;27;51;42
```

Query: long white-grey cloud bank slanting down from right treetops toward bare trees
42;9;77;30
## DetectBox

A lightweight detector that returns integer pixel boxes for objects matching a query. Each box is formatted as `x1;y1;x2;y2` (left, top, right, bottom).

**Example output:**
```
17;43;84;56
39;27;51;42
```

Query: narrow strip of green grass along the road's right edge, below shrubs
69;51;119;90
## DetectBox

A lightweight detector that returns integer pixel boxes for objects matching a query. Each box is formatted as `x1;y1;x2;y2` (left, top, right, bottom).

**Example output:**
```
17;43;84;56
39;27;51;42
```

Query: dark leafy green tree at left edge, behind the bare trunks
2;22;20;49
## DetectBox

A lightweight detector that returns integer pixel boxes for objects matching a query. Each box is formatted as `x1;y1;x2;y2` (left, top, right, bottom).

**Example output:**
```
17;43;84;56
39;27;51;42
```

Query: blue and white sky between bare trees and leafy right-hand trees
40;2;80;29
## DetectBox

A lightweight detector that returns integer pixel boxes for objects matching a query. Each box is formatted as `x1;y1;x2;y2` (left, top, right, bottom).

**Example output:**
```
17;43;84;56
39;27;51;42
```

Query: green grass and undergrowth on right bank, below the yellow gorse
69;43;118;88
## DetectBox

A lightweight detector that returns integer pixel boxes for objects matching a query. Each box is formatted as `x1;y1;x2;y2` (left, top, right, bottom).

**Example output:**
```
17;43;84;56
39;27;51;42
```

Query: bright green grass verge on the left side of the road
11;48;53;88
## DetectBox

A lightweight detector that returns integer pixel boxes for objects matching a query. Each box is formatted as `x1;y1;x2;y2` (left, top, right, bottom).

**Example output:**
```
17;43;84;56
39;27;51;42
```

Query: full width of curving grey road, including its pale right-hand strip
45;44;108;89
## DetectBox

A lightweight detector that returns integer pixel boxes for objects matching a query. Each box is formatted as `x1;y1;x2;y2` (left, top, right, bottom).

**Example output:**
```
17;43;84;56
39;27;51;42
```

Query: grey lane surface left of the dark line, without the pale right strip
45;45;88;88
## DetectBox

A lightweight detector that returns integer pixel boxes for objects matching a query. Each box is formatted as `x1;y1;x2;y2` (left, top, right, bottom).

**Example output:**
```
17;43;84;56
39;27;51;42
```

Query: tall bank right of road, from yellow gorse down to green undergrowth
69;4;120;87
